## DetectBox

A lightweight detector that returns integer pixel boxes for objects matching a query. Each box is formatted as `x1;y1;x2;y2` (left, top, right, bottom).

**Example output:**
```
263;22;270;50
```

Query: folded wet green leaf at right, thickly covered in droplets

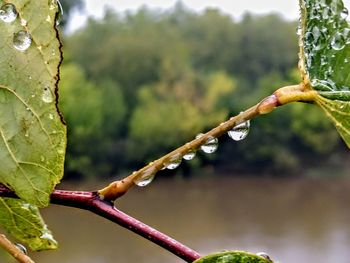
299;0;350;147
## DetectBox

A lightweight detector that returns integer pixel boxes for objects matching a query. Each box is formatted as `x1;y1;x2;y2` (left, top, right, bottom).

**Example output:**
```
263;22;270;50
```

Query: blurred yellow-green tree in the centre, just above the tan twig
130;70;235;160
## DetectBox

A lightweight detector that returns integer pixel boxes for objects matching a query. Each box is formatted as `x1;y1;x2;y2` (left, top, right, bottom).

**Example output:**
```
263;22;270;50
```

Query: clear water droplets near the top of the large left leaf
0;0;63;52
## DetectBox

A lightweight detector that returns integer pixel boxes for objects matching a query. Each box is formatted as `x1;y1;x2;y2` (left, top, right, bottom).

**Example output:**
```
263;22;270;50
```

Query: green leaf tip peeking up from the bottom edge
194;251;272;263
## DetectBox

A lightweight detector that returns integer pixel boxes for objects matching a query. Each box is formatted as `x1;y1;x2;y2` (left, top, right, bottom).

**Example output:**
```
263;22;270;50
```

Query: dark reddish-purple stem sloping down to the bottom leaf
0;184;200;262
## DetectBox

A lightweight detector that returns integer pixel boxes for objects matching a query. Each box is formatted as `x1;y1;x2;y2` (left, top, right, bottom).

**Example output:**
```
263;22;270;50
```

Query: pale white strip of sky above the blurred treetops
69;0;350;32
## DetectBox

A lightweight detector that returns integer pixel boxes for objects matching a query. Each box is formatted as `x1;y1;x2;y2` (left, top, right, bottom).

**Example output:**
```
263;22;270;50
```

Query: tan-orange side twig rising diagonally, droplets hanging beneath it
98;83;317;201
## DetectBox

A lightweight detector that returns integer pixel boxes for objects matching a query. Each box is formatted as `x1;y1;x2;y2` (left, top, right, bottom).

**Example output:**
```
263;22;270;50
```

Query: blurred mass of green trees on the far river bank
60;2;348;178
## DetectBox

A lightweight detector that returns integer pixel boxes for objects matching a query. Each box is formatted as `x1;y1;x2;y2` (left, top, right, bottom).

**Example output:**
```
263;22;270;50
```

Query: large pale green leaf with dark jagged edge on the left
0;0;66;207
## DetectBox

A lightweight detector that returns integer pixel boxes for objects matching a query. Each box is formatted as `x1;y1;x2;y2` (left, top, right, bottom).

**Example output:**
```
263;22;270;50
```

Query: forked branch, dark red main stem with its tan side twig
0;83;317;262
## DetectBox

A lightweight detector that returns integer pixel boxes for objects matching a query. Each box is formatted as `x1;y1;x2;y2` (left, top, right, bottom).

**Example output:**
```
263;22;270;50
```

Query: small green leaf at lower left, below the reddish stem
0;198;57;250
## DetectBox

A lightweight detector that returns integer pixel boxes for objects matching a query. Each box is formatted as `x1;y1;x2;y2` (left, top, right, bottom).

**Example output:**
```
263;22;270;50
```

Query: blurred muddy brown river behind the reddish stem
0;177;350;263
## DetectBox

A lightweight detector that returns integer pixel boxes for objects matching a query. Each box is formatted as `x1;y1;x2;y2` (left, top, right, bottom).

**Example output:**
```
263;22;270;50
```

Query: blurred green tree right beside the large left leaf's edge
60;64;125;177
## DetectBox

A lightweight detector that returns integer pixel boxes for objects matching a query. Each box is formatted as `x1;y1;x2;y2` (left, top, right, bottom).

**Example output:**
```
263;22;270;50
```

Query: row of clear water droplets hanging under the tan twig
134;120;250;187
